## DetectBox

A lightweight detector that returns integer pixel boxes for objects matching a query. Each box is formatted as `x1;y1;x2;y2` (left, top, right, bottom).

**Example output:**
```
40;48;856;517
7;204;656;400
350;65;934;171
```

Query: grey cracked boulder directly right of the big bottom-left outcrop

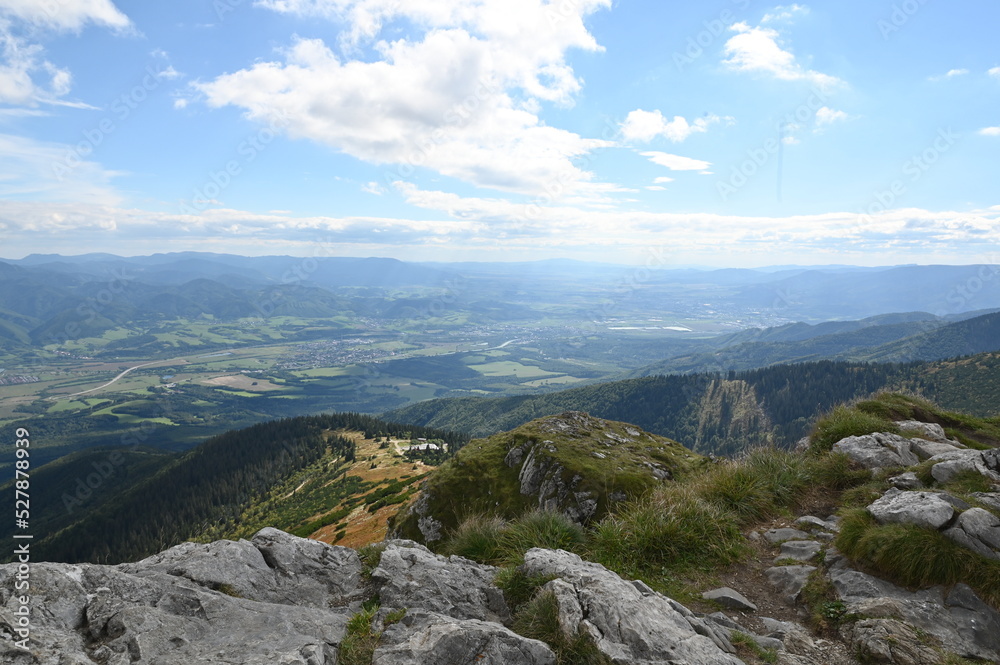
371;543;510;623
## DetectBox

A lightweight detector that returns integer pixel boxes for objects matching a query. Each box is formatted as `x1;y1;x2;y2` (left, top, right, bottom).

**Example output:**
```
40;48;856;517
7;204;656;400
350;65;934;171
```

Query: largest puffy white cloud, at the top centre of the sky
197;0;613;195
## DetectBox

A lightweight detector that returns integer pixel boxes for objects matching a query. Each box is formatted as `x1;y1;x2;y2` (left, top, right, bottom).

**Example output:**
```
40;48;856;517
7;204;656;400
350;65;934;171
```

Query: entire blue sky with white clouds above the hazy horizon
0;0;1000;267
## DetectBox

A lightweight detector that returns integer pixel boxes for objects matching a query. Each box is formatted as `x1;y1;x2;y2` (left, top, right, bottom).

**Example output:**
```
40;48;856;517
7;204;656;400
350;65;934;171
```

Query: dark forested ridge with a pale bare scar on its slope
386;353;1000;455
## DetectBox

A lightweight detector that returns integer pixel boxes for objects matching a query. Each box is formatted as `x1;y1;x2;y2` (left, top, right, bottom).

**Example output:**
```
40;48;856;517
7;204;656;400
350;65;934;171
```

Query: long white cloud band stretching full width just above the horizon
0;196;1000;265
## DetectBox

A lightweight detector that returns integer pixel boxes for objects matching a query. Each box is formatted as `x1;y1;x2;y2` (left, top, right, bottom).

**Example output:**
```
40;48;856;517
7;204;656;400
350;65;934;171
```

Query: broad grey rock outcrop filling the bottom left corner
0;529;361;665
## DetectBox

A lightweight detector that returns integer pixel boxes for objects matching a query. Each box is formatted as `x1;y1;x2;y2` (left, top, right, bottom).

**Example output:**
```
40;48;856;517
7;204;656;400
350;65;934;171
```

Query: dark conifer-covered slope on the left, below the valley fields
0;413;468;562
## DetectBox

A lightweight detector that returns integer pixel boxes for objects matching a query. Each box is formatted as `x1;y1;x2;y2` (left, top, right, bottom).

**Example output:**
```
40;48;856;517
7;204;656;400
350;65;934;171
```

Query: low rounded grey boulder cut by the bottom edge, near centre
374;610;556;665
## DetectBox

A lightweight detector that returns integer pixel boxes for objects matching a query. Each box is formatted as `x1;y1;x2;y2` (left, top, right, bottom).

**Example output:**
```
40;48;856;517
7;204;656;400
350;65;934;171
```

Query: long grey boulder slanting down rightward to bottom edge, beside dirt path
523;548;742;665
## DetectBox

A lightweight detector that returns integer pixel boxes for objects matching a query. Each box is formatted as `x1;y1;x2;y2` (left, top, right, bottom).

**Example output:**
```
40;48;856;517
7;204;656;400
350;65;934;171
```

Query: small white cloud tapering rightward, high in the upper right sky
723;22;844;90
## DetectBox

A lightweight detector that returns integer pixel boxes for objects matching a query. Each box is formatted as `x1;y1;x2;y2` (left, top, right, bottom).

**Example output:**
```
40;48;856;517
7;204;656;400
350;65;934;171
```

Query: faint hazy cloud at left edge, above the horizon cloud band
0;134;122;205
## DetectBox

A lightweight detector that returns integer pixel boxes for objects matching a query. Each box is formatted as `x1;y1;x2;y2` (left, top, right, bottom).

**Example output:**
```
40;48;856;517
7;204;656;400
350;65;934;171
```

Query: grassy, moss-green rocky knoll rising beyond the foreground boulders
390;411;707;544
